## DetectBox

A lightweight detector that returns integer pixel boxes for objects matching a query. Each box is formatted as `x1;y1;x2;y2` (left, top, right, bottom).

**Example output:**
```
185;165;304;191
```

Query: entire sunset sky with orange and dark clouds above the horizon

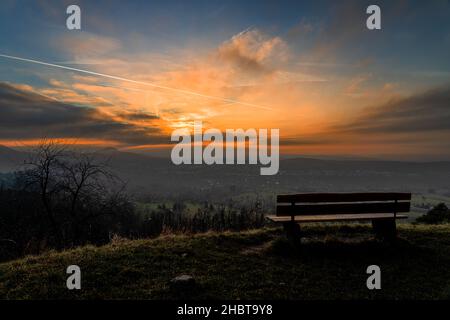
0;0;450;160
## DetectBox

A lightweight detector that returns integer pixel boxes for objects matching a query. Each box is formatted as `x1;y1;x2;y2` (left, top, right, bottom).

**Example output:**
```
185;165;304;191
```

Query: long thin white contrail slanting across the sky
0;54;272;110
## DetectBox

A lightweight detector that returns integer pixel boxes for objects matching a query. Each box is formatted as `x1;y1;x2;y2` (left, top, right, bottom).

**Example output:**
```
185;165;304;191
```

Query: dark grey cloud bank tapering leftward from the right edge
333;87;450;133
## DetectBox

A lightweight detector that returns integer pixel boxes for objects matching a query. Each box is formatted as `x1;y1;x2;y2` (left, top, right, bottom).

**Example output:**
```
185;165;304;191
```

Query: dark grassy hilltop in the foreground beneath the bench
0;224;450;299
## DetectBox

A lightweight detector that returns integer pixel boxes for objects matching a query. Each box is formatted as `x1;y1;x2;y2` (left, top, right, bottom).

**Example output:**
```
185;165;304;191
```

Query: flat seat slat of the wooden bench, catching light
266;213;408;222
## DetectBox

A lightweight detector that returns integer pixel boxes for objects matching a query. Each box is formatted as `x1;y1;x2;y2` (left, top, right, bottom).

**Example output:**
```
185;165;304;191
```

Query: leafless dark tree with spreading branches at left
22;140;126;247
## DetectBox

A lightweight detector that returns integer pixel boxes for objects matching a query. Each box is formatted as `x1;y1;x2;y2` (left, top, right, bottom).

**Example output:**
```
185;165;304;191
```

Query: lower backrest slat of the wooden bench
277;202;410;216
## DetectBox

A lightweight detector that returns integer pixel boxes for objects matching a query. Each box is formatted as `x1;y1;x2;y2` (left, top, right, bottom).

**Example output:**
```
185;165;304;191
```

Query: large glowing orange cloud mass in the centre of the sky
6;27;418;156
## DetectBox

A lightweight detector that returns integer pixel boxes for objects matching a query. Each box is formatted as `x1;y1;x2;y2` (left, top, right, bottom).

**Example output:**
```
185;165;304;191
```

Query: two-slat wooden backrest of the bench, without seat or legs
277;192;411;216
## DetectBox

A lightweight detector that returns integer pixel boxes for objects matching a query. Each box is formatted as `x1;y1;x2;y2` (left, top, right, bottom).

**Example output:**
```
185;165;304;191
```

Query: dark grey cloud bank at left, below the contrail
0;83;168;145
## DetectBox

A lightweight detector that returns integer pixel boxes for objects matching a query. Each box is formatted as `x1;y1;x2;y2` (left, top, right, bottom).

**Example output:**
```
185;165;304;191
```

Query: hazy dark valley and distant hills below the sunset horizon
0;147;450;200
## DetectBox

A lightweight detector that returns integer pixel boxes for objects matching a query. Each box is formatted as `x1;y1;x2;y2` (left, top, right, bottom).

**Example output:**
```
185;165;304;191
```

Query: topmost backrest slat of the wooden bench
277;192;411;203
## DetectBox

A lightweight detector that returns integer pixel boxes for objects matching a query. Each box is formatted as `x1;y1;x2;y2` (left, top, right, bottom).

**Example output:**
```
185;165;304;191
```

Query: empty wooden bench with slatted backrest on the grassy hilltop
267;192;411;245
